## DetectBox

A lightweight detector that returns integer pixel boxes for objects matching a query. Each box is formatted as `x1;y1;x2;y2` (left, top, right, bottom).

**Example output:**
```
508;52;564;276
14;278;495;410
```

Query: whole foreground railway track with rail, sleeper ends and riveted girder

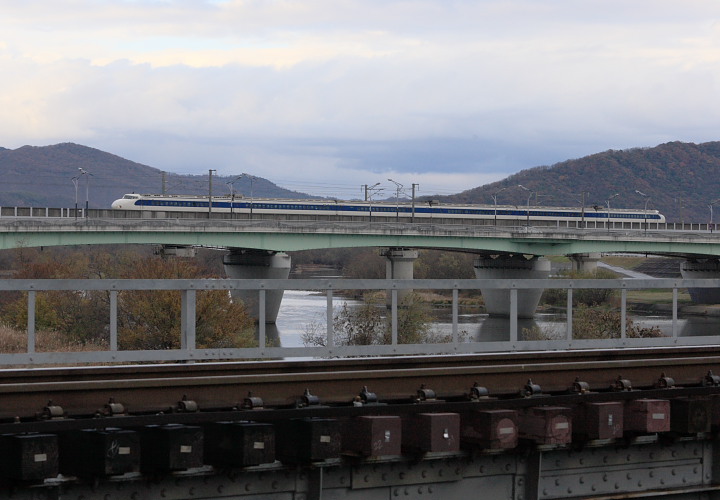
0;346;720;500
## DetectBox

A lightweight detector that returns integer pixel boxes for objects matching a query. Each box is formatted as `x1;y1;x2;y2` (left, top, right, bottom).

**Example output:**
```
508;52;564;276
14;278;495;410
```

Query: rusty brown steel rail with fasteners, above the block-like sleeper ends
0;346;720;432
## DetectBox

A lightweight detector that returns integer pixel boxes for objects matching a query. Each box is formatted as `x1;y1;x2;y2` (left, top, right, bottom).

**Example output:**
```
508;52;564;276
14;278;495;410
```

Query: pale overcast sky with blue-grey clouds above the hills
0;0;720;197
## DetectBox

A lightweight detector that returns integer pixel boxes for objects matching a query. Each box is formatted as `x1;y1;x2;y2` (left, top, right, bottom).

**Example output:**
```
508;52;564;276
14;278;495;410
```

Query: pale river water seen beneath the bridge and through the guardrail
267;269;720;347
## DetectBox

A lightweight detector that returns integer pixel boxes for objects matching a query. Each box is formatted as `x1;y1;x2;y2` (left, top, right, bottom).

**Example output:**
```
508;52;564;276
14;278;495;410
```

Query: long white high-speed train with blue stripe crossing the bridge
112;193;665;226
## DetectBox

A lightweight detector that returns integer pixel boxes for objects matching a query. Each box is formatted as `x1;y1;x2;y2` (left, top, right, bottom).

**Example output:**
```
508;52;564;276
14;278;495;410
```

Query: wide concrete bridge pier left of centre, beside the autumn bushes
223;248;290;323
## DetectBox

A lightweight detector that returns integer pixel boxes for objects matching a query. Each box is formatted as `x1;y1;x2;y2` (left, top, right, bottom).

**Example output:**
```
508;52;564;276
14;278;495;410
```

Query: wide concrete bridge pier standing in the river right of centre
473;255;550;318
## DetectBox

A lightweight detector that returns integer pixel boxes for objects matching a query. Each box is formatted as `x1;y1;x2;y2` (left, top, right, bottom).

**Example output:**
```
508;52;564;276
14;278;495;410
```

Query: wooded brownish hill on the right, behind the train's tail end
433;142;720;222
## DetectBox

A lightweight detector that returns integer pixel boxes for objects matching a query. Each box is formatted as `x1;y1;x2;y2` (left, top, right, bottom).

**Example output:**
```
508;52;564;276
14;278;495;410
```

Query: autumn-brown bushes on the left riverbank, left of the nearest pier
0;248;254;349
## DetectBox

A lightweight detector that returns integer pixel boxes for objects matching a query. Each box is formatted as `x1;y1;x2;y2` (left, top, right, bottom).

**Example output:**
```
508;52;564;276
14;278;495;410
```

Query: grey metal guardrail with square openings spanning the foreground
0;279;720;365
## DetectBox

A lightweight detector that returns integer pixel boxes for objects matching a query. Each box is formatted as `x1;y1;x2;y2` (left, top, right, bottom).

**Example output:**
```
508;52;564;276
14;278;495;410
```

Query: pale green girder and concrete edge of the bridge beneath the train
0;221;720;258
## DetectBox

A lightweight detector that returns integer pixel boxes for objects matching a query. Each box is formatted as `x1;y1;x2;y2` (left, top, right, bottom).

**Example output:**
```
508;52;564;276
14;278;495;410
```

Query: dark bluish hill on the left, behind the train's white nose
0;143;311;208
